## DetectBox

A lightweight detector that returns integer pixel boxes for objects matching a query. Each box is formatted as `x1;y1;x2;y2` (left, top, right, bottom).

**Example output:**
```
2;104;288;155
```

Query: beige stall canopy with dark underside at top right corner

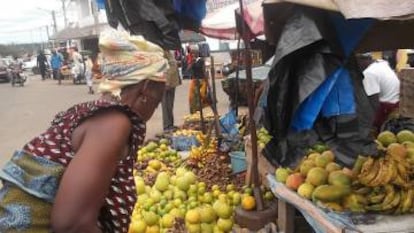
263;0;414;52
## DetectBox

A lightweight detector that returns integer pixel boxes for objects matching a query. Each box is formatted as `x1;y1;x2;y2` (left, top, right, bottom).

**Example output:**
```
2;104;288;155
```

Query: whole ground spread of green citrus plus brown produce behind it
129;124;274;233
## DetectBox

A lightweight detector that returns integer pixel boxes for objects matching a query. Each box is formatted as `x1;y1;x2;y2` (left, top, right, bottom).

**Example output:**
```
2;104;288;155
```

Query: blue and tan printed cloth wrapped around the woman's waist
0;151;64;233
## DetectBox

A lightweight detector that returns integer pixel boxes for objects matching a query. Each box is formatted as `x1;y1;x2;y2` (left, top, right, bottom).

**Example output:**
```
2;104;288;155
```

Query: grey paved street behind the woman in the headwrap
0;76;229;166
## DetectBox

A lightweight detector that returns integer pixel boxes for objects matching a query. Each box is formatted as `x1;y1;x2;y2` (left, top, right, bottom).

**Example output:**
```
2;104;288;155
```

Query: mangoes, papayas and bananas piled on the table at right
275;130;414;214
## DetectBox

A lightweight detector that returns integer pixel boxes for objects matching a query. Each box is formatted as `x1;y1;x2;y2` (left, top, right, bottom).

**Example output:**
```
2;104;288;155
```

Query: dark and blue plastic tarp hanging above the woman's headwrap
105;0;206;50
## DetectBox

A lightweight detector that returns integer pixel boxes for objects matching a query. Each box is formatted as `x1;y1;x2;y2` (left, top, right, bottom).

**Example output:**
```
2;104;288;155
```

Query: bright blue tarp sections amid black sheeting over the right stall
291;14;374;132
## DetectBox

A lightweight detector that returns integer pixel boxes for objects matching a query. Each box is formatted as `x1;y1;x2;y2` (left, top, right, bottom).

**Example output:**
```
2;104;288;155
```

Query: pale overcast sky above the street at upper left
0;0;75;44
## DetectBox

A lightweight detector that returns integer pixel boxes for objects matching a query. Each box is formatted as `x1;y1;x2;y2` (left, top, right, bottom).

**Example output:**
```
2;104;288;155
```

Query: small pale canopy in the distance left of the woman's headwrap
50;23;109;40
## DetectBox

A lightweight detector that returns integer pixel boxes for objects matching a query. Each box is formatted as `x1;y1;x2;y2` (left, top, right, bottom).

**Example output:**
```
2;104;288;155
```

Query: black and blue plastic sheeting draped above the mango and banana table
264;8;377;167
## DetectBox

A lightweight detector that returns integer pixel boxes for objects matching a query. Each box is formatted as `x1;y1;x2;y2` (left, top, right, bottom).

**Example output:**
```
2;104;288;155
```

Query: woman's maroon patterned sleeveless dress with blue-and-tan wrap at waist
0;100;146;233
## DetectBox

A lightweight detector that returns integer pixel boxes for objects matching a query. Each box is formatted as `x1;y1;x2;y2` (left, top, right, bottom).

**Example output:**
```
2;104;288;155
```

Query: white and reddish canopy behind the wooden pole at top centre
200;0;264;40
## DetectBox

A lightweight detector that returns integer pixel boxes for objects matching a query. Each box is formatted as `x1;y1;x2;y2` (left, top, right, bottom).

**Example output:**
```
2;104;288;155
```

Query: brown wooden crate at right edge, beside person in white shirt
398;68;414;118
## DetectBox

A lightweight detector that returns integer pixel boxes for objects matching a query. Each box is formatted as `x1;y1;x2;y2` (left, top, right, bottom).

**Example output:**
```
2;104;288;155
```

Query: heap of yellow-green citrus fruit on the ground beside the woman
129;167;270;233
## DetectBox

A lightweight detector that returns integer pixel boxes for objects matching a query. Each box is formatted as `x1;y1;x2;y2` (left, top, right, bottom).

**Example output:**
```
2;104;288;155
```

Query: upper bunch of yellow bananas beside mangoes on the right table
358;155;411;188
